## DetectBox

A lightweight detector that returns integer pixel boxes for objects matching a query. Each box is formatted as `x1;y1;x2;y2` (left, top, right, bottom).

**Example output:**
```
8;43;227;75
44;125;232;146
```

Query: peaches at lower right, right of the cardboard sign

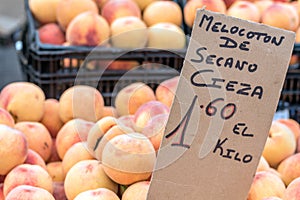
248;119;300;200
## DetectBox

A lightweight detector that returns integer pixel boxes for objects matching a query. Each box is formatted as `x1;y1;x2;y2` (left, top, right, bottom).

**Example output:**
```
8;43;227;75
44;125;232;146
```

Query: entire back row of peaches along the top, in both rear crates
29;0;300;49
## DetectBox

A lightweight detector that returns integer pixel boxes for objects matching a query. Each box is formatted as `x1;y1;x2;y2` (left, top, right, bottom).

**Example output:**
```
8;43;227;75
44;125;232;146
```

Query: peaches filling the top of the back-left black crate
29;0;186;49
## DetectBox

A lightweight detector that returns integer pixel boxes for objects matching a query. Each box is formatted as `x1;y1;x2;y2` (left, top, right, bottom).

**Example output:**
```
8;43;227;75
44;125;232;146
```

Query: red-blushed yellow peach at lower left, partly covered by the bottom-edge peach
3;164;53;196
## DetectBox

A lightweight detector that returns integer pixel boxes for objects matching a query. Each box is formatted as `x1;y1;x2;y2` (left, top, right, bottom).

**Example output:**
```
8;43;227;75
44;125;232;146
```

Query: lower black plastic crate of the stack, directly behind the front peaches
25;60;178;105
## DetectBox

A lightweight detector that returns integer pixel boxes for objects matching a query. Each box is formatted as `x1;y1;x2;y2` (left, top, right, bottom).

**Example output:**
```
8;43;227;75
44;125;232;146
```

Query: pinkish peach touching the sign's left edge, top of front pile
155;76;179;108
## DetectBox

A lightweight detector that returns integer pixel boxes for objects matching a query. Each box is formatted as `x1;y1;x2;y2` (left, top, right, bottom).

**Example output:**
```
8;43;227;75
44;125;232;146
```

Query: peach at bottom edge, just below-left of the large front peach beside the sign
65;160;118;200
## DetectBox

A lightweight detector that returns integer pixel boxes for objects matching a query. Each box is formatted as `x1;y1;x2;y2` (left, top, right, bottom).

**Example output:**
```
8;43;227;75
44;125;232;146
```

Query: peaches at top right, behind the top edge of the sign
184;0;300;34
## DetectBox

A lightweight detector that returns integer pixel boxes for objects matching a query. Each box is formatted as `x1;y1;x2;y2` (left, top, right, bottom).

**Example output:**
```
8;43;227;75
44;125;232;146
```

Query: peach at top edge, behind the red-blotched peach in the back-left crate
56;0;99;30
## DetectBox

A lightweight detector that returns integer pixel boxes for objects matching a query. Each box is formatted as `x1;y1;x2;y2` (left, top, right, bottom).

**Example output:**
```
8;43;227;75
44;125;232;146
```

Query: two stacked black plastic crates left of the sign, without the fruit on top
23;45;185;105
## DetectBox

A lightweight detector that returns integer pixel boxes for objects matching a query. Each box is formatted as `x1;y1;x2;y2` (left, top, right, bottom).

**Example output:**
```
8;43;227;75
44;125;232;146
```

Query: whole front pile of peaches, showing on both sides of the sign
0;79;300;200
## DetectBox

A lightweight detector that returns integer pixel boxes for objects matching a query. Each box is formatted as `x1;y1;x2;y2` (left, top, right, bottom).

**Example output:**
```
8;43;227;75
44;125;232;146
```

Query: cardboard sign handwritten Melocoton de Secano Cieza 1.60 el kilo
148;9;295;200
